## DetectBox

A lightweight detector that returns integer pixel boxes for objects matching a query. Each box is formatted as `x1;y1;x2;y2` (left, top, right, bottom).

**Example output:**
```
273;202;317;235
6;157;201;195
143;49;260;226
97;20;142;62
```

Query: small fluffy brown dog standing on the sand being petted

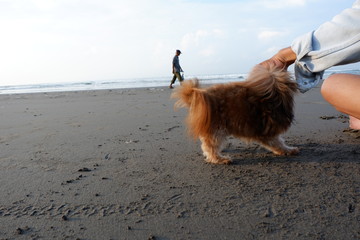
171;65;299;164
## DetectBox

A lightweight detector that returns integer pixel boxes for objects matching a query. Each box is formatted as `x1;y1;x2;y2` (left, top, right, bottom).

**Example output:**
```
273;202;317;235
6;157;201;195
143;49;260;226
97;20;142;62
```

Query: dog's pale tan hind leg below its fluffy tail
200;136;231;164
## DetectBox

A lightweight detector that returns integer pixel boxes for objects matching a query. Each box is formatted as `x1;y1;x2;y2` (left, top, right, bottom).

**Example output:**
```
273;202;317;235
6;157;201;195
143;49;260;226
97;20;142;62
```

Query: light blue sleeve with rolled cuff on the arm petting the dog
291;0;360;92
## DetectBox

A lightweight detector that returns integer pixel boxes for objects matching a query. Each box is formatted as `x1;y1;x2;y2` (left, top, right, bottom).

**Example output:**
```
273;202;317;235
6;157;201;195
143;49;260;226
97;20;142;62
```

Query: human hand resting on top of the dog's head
260;47;296;70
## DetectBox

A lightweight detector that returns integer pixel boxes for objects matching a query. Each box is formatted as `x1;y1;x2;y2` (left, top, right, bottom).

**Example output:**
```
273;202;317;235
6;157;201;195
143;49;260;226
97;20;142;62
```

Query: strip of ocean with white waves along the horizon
0;69;360;94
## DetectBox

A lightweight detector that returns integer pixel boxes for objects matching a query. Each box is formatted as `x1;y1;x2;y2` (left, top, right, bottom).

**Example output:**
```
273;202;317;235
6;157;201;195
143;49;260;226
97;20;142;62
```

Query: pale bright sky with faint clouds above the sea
0;0;354;85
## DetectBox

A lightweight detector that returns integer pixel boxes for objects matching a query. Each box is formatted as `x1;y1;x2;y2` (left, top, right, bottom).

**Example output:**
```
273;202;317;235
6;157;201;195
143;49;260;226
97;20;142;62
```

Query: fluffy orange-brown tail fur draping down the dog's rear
171;78;211;139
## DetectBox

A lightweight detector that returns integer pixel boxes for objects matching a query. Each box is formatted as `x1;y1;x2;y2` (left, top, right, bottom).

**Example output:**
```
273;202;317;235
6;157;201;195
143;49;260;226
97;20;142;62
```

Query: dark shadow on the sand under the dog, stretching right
222;143;360;166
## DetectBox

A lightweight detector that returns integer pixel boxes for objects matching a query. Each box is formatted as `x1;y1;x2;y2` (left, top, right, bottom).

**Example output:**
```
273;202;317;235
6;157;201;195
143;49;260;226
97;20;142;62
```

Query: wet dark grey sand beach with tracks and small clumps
0;87;360;240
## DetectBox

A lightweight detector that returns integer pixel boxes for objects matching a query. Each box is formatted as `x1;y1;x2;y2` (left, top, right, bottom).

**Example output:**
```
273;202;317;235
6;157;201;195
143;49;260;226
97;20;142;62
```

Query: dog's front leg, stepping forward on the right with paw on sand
259;136;299;155
